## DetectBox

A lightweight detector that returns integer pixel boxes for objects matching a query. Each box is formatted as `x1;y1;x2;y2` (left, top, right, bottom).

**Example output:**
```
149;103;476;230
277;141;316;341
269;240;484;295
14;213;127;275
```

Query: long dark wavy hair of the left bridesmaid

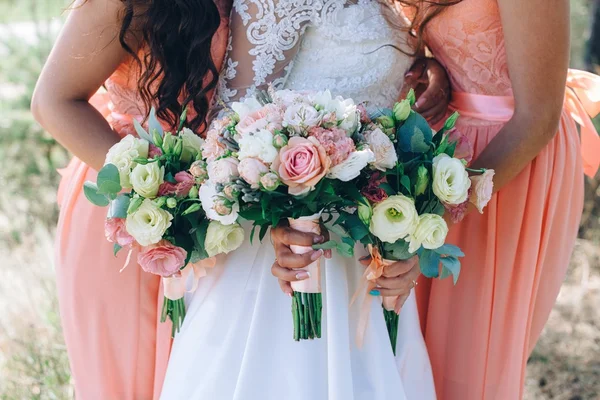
81;0;227;133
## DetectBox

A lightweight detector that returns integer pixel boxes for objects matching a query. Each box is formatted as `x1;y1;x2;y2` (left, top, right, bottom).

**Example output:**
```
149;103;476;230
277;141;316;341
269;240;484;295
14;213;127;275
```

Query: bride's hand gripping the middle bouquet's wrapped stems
271;220;331;296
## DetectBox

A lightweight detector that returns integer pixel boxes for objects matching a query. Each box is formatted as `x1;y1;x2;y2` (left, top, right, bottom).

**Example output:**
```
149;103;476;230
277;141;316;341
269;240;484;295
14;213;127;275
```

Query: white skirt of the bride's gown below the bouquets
161;228;435;400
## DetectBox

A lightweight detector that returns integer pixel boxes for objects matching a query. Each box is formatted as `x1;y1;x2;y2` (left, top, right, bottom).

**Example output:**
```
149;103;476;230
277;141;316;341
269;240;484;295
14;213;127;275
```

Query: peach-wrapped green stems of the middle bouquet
288;214;323;341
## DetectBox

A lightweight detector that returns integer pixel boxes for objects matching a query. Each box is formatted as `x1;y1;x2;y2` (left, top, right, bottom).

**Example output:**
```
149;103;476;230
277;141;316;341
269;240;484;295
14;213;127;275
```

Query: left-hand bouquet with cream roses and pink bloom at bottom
83;110;244;335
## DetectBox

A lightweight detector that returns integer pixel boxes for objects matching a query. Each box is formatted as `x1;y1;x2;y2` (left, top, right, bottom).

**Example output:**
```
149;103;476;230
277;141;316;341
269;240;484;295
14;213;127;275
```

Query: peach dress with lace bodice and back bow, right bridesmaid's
417;0;600;400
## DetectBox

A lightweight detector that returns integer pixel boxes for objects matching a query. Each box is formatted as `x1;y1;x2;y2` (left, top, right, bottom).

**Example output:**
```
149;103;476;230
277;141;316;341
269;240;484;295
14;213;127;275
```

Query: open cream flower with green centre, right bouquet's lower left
369;195;419;243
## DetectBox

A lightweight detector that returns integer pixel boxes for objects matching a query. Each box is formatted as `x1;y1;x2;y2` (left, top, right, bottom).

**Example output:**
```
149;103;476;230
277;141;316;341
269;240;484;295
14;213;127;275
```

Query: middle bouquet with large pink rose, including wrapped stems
200;90;375;340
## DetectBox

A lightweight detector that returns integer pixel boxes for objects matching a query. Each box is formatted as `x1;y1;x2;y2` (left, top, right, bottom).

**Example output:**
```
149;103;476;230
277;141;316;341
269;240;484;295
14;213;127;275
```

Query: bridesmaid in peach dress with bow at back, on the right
407;0;600;400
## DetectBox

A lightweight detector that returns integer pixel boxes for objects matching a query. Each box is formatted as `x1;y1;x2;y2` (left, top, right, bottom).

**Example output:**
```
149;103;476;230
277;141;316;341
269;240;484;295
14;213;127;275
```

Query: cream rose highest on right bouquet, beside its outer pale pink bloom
432;154;471;205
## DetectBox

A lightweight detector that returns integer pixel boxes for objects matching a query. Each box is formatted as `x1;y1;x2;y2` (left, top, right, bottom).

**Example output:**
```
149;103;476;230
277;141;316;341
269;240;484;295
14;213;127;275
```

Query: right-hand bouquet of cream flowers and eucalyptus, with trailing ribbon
335;91;494;353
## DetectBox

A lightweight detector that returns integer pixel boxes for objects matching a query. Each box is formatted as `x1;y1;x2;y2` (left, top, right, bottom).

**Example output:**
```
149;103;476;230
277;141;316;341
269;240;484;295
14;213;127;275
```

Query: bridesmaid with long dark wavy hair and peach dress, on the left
32;0;229;400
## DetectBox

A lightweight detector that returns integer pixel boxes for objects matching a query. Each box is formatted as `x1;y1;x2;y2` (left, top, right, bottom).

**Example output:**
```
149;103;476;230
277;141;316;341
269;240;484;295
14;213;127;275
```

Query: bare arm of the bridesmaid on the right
473;0;569;191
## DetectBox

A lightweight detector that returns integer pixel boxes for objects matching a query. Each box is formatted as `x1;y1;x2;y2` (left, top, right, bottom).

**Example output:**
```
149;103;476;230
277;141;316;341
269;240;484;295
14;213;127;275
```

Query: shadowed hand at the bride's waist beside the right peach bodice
400;58;450;124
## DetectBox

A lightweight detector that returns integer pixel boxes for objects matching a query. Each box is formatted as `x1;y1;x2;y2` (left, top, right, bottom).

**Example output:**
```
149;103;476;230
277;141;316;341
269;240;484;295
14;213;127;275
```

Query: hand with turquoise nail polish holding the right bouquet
360;256;421;314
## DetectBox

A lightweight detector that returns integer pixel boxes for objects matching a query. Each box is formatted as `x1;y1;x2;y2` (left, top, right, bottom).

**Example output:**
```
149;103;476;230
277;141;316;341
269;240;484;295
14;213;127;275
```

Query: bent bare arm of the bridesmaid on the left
31;0;138;169
